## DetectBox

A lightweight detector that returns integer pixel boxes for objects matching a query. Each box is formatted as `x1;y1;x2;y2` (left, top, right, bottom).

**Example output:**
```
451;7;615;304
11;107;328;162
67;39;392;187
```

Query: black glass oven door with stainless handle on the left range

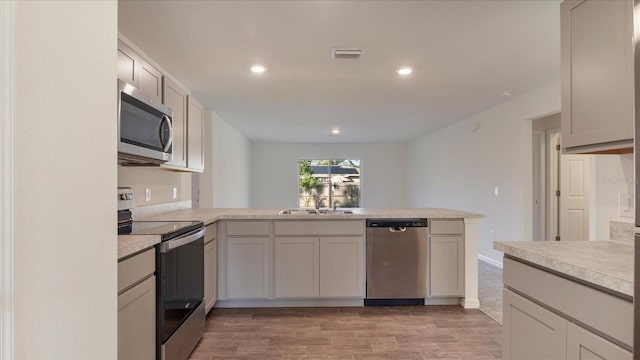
156;229;205;344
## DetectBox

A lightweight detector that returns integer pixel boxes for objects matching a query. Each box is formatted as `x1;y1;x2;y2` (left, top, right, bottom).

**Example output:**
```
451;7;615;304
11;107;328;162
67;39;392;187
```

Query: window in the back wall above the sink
298;160;360;208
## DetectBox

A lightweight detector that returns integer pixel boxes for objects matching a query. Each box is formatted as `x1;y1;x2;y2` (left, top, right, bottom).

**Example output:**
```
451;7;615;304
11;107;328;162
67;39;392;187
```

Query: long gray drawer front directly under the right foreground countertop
503;258;633;346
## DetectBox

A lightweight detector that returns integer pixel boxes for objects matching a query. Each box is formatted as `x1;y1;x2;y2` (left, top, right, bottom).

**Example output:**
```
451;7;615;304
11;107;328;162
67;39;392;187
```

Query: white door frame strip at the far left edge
0;0;16;359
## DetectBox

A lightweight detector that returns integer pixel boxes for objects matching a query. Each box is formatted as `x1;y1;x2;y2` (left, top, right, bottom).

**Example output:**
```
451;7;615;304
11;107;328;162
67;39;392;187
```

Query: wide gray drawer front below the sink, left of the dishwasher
275;220;364;235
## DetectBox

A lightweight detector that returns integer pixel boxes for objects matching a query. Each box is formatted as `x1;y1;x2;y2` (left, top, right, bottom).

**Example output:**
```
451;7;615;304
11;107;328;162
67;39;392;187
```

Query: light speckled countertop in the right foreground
493;241;633;296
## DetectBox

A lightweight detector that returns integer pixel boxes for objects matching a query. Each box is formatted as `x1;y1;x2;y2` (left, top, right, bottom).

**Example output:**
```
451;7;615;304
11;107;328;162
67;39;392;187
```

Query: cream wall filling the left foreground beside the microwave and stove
13;1;118;359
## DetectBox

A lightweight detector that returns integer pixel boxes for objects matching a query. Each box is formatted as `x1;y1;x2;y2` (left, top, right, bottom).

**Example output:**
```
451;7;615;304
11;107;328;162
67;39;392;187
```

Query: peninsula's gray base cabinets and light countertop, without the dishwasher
118;208;483;308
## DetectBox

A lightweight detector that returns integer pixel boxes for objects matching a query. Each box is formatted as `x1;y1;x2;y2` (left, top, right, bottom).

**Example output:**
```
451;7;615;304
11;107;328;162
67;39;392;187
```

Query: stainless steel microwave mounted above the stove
118;80;173;165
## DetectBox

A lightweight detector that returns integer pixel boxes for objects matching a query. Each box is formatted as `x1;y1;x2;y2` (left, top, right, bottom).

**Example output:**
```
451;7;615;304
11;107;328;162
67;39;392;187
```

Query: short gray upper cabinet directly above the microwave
118;40;162;103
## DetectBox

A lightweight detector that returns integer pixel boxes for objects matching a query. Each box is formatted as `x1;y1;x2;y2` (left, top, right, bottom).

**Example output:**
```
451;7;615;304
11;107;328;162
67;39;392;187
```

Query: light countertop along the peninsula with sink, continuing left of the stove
118;208;484;259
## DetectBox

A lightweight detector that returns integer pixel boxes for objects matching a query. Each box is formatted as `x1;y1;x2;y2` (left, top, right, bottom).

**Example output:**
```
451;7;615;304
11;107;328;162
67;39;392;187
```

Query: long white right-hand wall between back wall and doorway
407;80;560;262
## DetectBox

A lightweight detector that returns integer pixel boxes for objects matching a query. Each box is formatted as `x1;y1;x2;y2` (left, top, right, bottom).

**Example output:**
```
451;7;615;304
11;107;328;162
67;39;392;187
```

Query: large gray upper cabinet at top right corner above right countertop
561;0;634;153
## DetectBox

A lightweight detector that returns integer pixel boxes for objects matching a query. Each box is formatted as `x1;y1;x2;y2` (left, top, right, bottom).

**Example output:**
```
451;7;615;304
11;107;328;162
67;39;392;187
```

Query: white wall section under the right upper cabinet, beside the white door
589;154;634;240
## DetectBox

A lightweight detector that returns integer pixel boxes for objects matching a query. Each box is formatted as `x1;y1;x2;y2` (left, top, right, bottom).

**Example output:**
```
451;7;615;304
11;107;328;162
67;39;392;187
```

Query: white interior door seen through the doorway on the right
560;149;589;241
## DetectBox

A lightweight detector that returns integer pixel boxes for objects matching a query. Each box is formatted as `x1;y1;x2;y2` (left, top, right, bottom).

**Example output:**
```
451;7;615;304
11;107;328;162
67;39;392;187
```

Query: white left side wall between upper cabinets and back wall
200;111;251;208
